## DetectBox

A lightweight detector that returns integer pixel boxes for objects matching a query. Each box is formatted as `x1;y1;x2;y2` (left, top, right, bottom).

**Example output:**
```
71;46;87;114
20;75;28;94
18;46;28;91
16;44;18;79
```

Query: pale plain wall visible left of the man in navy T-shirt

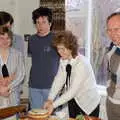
16;0;39;98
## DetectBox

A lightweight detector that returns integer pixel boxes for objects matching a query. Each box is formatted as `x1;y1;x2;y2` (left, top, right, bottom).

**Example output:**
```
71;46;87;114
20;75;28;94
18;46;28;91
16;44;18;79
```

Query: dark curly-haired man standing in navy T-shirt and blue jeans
28;7;59;108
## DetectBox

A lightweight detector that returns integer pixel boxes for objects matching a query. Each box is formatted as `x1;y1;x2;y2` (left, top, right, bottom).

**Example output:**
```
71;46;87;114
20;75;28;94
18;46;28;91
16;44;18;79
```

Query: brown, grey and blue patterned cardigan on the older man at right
107;45;120;105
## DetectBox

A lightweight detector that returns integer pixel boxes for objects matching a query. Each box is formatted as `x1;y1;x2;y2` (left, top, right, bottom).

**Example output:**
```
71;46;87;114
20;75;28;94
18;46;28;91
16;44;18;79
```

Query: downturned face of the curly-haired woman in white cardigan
57;44;72;60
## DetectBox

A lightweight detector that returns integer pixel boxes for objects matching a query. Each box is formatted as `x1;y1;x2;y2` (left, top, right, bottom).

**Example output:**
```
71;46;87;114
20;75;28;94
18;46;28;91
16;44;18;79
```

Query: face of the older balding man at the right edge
107;15;120;46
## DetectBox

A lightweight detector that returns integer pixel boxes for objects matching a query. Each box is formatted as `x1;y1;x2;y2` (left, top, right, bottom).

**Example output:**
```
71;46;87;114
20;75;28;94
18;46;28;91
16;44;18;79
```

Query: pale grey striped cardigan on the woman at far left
0;48;25;108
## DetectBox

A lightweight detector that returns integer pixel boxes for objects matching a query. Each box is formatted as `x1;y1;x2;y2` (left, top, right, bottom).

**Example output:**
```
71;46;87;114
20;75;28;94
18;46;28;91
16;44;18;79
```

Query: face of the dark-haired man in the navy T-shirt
36;16;51;36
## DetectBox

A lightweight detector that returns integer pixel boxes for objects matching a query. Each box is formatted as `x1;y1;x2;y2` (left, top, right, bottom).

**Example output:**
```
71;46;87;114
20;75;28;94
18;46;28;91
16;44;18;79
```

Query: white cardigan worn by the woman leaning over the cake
48;55;100;115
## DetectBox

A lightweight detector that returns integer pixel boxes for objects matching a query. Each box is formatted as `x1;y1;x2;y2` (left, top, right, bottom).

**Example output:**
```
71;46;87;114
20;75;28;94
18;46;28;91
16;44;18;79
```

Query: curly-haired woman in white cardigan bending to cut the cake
44;31;100;118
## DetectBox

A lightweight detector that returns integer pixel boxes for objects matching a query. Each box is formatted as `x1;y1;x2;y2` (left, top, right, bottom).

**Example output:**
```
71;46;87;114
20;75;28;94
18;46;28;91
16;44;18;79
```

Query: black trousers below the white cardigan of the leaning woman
68;99;99;118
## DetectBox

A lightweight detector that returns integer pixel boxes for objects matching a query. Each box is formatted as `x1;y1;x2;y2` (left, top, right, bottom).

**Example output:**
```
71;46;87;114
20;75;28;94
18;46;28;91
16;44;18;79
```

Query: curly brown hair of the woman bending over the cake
52;31;79;58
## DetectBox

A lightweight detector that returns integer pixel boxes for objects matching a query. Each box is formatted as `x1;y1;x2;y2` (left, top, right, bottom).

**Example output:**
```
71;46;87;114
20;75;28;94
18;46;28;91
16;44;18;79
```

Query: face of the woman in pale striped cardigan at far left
0;33;11;49
